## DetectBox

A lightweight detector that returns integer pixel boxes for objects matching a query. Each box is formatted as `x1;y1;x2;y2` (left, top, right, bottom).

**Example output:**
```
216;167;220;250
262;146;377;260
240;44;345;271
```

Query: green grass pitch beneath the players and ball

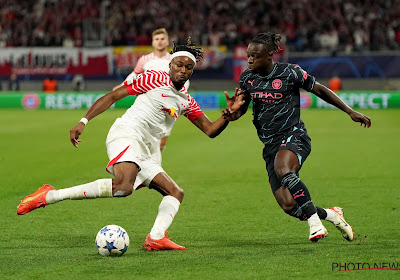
0;110;400;279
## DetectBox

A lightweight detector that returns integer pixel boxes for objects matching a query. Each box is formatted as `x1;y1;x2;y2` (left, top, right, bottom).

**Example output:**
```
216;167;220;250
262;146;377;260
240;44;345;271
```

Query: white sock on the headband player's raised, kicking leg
46;179;112;204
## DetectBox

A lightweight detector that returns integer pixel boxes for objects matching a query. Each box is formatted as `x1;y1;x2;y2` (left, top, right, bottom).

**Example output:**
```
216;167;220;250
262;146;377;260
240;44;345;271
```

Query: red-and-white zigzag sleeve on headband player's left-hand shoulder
124;71;164;95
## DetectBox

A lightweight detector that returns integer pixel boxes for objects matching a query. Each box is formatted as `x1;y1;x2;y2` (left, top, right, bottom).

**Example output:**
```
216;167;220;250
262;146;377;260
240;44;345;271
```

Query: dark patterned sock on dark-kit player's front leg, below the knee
281;172;317;219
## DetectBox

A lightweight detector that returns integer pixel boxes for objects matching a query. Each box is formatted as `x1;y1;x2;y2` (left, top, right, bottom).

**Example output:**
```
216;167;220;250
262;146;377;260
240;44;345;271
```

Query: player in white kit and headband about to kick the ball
17;40;244;251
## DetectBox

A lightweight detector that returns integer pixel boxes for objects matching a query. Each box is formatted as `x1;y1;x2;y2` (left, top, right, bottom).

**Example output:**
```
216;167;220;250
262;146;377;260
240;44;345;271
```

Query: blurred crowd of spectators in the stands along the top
0;0;400;52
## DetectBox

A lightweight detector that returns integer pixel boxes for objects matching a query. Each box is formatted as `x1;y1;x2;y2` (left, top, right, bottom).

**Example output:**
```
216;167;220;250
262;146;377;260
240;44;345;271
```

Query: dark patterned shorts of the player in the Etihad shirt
263;126;311;193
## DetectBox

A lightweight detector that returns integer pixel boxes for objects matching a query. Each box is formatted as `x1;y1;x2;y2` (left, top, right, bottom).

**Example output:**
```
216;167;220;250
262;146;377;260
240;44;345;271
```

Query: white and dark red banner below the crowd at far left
0;48;113;76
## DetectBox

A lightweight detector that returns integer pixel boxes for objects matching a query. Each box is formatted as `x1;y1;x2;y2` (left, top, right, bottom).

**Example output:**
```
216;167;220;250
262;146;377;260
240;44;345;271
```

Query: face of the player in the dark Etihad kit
247;43;272;72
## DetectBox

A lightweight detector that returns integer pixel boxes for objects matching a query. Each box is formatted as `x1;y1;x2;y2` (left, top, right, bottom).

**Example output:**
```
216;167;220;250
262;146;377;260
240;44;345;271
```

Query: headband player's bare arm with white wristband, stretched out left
69;87;128;148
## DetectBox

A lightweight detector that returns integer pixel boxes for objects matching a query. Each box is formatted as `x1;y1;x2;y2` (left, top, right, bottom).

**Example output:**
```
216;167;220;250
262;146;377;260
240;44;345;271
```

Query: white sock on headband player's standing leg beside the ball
150;195;181;239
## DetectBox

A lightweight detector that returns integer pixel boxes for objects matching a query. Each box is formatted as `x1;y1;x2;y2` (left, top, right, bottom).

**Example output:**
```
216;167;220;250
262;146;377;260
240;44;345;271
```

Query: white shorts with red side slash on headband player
106;123;165;190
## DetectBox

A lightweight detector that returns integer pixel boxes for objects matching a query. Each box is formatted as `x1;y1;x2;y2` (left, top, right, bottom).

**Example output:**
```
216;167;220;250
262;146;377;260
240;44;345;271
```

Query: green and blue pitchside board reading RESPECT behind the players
0;91;400;110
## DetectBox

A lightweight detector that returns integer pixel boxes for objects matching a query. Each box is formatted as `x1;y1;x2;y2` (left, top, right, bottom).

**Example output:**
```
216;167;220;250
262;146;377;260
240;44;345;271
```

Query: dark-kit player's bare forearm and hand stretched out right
311;82;371;127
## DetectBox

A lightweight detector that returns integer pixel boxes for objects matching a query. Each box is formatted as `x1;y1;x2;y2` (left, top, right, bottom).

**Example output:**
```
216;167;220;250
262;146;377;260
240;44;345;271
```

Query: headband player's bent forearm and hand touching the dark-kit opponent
193;93;243;138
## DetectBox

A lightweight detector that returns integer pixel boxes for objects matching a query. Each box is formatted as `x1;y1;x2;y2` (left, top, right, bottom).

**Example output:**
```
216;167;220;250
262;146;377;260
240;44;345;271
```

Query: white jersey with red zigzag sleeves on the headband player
121;70;204;142
